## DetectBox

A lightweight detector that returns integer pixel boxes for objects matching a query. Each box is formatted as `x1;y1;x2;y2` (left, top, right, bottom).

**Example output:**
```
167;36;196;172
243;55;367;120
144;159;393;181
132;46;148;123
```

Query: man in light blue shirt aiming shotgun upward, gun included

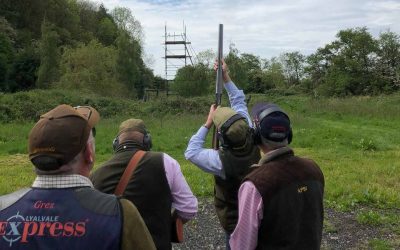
185;25;260;249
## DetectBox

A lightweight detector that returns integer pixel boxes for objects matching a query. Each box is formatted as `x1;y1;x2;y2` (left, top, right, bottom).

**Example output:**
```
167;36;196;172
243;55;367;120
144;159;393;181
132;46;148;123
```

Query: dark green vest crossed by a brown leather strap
90;147;172;250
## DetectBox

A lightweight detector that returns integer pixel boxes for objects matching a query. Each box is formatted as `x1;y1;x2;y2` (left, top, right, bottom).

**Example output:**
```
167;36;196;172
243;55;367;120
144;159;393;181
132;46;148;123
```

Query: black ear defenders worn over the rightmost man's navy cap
253;106;293;145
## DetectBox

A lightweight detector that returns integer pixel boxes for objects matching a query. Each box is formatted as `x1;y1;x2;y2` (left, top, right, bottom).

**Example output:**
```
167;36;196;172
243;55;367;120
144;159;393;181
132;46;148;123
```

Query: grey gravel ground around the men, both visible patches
173;198;398;250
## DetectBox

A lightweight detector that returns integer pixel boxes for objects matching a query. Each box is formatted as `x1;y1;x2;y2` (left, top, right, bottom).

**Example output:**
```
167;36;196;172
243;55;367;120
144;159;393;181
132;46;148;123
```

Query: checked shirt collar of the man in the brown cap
32;174;93;188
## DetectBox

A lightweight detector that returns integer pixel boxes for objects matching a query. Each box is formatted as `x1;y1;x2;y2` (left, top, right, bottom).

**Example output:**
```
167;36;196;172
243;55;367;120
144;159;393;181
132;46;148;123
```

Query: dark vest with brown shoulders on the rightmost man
243;147;324;249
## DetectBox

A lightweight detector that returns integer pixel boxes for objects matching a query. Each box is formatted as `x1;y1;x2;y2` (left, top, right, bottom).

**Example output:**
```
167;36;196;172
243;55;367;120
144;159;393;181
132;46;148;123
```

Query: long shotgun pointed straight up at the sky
212;24;224;150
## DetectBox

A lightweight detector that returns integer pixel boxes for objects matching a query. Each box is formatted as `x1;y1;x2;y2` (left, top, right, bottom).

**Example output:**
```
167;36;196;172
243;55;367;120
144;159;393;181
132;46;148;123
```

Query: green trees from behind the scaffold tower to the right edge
173;27;400;97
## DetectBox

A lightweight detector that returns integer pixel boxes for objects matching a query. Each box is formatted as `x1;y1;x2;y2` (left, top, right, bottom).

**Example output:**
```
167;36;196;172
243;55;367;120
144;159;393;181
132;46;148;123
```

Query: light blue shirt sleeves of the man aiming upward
185;82;252;179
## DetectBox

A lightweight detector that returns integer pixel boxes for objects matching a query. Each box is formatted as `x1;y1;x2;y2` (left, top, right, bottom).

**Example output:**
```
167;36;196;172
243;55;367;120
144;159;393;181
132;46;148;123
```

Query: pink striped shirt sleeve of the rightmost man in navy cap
229;181;263;250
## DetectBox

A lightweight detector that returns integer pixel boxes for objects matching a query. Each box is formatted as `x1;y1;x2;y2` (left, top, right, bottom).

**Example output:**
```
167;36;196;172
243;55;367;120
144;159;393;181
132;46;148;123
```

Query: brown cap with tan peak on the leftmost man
28;104;100;170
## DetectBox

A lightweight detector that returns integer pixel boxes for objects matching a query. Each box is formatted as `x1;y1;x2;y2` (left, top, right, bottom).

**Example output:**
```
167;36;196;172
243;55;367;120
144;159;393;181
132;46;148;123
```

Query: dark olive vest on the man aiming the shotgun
214;143;260;233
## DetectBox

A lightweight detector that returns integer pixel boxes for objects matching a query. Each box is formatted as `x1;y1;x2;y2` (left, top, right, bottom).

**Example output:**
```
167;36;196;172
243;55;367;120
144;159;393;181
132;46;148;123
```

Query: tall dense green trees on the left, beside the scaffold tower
0;0;160;98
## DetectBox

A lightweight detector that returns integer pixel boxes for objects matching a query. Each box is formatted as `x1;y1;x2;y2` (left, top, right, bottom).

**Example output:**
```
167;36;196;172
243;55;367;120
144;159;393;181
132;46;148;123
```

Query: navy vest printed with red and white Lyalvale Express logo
0;187;122;250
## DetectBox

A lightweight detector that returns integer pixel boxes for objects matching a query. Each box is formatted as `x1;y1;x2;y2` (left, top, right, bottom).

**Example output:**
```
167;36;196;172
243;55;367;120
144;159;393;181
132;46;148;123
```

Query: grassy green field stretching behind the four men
0;95;400;246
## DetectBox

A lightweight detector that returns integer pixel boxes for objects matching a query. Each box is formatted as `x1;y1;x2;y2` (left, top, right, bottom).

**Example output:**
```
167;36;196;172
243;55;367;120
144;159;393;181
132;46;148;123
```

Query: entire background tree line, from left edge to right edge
0;0;400;98
